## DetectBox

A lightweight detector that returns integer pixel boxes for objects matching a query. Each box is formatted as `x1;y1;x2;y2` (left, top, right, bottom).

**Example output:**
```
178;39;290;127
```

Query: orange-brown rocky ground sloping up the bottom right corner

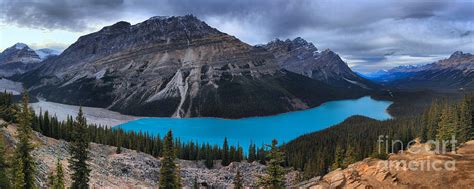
296;141;474;189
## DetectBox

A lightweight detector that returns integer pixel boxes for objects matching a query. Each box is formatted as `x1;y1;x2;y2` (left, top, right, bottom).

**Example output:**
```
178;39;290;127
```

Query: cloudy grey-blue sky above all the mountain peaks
0;0;474;72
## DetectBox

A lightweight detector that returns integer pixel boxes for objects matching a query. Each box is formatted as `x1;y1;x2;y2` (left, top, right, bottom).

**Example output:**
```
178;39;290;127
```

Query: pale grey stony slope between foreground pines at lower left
0;125;297;188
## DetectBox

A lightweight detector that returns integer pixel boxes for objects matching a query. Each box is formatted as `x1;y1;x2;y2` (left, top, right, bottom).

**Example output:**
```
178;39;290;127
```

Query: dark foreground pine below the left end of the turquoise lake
160;130;181;189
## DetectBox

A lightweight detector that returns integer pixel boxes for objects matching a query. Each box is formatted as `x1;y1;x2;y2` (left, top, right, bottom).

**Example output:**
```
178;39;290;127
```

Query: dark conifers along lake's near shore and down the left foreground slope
0;93;283;189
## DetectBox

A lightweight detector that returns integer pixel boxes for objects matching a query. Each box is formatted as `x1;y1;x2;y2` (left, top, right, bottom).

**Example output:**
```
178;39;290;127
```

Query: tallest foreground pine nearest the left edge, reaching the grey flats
13;90;36;188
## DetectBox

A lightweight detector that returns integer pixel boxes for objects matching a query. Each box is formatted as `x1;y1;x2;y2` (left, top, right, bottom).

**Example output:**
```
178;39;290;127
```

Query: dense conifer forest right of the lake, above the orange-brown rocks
282;94;474;179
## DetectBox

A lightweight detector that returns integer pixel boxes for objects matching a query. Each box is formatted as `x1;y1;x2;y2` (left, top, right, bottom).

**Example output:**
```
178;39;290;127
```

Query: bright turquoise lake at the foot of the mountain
116;97;392;152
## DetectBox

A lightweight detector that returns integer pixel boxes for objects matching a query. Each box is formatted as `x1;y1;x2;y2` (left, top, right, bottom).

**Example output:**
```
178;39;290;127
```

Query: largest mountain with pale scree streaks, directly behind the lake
15;16;362;118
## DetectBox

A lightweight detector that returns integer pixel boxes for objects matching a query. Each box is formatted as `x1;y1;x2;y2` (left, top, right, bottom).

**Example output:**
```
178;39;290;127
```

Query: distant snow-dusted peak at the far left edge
0;43;59;77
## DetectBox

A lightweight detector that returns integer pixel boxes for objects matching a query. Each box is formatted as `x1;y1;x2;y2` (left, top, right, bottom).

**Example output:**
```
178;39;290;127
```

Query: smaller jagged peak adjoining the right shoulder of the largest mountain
262;37;376;91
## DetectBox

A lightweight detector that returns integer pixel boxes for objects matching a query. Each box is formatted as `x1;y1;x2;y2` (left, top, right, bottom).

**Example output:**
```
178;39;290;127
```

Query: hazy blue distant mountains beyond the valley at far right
364;51;474;91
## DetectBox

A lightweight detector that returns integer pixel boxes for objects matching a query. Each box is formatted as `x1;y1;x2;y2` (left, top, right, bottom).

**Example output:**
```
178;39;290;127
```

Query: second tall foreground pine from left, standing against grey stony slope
69;107;91;189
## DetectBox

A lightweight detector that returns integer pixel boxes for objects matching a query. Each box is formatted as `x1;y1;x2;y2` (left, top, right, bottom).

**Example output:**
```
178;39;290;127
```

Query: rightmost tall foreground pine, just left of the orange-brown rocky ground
258;139;286;189
